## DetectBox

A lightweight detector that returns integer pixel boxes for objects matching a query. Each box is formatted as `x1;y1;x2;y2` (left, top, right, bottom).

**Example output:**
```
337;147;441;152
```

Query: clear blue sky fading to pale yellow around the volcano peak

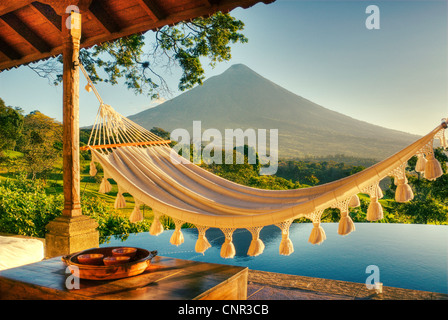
0;0;448;135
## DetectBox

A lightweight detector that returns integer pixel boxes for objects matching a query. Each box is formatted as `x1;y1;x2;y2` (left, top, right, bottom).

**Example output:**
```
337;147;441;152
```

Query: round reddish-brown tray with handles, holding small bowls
62;247;157;280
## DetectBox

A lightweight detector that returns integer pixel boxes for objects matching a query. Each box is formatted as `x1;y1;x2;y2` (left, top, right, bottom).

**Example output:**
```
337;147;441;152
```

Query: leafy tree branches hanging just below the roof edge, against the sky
29;12;247;99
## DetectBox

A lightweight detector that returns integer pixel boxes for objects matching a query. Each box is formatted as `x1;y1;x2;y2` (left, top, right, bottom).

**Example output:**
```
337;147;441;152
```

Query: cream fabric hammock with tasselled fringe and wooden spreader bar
81;66;447;258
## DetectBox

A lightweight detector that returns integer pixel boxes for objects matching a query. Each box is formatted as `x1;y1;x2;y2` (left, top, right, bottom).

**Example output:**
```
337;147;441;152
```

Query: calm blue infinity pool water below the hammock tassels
101;223;448;293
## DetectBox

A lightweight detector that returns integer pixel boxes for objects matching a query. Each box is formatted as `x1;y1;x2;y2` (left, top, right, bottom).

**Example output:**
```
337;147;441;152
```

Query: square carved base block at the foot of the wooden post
45;215;99;258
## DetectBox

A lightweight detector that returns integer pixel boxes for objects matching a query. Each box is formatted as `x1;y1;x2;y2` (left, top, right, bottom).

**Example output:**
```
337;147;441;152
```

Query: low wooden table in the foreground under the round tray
0;256;248;300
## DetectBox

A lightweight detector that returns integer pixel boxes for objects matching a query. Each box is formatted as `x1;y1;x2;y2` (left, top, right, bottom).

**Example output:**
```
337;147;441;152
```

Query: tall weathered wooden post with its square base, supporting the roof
46;12;99;257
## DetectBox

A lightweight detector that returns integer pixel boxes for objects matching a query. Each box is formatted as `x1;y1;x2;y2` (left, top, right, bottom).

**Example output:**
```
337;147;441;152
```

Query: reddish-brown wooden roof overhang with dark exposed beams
0;0;275;71
